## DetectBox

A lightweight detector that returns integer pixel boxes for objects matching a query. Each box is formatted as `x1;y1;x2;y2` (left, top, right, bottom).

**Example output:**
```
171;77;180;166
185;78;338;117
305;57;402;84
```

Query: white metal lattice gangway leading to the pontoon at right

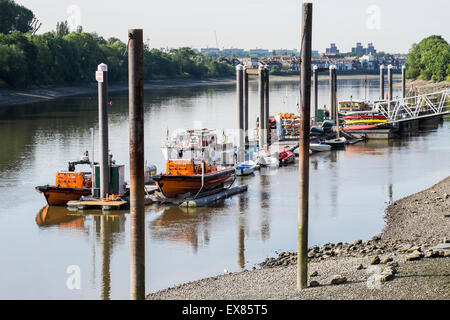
374;88;450;123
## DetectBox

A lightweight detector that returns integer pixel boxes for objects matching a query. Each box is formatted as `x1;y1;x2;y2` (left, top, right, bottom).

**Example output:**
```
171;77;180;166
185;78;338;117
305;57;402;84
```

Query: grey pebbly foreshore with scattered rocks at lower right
147;177;450;300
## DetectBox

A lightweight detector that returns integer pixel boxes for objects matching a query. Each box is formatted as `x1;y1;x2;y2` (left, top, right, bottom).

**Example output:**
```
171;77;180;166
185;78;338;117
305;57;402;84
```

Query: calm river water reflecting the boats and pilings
0;76;450;299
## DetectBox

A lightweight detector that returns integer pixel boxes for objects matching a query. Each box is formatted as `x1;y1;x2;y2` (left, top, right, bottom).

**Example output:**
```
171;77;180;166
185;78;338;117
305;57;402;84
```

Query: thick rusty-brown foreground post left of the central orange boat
128;29;145;300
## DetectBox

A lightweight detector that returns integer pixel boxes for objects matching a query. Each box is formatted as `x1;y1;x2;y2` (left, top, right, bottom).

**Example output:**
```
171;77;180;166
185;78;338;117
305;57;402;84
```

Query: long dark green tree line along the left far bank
0;0;234;87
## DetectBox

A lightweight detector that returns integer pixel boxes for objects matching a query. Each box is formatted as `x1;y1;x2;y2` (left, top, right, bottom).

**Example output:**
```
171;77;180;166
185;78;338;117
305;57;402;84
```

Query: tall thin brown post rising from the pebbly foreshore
297;3;312;290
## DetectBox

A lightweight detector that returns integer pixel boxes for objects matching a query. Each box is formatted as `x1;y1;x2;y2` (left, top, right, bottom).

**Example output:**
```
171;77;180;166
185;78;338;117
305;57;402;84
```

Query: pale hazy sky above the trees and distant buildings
17;0;450;53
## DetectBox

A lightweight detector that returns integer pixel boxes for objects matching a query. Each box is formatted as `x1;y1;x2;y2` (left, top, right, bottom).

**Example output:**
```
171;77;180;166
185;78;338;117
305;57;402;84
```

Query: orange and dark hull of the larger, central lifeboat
153;168;235;198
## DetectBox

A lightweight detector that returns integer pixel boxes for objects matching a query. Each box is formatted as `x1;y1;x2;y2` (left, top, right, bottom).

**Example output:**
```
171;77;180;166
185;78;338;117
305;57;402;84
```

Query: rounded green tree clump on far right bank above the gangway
406;35;450;82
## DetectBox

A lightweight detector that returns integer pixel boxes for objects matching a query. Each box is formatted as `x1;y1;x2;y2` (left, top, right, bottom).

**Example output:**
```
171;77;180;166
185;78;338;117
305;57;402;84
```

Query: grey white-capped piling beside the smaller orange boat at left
95;63;109;198
